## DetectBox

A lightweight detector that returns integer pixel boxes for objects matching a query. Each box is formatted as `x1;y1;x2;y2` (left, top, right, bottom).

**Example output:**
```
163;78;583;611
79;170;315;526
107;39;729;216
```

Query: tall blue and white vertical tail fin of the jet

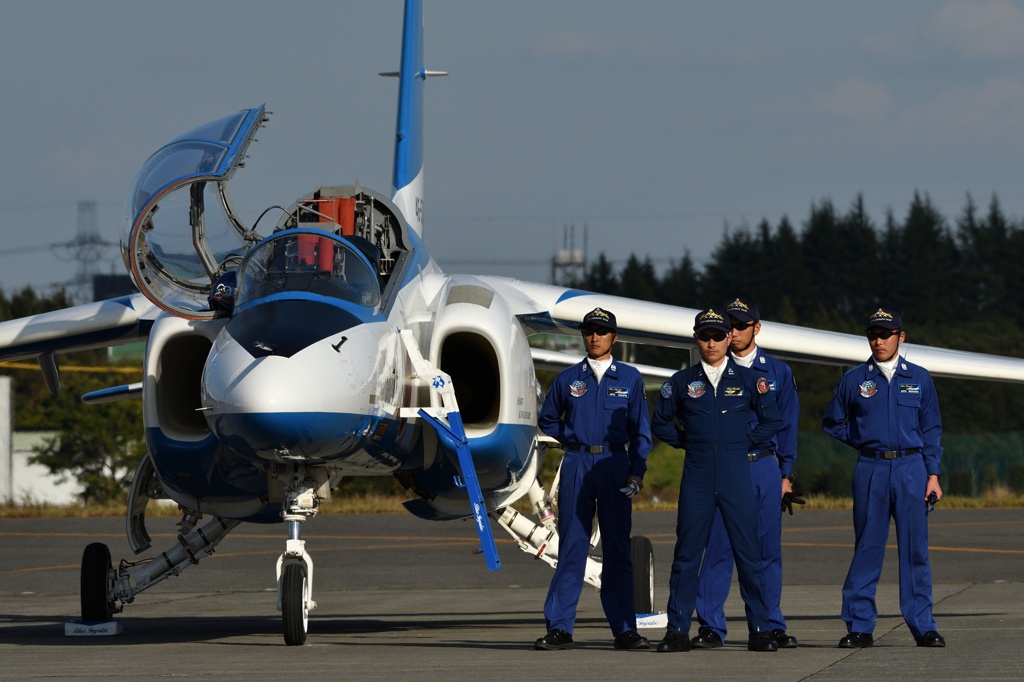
381;0;447;237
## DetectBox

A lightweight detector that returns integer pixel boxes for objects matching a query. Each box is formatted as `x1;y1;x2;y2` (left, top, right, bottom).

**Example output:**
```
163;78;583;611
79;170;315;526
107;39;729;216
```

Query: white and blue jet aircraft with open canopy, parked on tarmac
0;0;1024;645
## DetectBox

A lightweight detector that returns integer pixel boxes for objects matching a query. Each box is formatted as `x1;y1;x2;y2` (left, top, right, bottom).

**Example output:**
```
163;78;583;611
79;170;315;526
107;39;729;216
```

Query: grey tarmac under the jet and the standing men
0;503;1024;681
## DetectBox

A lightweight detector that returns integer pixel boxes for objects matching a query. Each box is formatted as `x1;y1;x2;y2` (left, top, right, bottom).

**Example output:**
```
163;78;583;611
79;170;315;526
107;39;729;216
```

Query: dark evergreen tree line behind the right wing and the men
570;194;1024;495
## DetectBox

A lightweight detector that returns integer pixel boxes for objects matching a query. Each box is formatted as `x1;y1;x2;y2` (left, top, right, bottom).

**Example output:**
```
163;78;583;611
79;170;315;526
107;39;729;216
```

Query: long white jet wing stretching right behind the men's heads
479;275;1024;383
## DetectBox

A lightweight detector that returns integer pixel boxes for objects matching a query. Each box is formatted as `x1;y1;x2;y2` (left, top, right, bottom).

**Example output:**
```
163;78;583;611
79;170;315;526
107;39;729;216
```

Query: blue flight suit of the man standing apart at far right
821;357;942;639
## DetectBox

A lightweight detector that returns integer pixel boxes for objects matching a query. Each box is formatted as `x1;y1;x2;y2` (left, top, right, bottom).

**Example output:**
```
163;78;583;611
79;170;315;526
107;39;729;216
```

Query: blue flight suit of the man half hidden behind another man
697;346;800;640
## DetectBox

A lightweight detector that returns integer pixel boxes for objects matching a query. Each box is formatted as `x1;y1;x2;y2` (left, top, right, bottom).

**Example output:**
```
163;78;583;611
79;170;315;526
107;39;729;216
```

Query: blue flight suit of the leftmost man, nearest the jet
537;352;652;637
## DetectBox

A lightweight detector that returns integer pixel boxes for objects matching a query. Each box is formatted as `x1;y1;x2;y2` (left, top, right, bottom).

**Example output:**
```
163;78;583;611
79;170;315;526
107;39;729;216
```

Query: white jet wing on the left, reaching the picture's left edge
0;294;160;393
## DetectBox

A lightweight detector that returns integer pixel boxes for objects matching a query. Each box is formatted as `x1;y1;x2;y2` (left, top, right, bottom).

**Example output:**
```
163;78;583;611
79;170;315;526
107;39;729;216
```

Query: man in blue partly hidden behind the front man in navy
690;298;803;649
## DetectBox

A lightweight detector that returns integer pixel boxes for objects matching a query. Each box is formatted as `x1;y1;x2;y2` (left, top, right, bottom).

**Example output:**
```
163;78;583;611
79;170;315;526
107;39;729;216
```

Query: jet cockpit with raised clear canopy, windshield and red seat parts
121;106;414;319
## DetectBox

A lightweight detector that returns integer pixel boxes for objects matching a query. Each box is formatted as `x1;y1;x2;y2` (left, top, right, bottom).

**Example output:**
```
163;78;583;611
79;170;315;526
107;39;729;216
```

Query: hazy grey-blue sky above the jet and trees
0;0;1024;292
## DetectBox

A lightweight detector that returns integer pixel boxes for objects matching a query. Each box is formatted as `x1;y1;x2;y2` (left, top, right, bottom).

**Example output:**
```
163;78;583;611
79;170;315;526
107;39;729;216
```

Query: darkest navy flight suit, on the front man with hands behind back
651;359;782;635
